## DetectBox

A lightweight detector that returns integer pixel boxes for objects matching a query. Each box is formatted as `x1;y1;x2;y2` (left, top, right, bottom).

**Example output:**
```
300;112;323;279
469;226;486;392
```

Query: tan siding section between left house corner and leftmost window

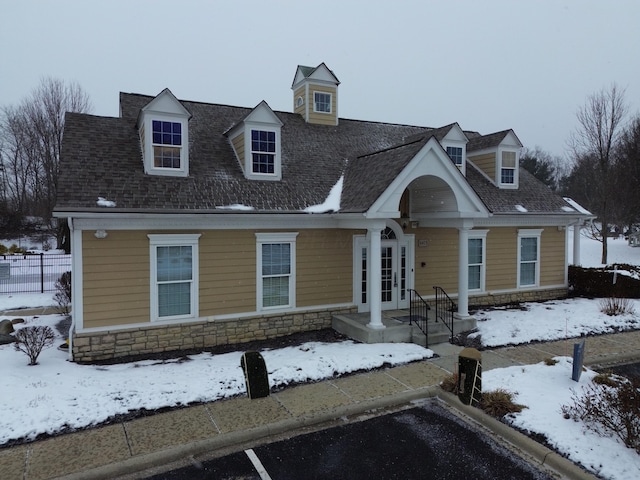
82;230;149;328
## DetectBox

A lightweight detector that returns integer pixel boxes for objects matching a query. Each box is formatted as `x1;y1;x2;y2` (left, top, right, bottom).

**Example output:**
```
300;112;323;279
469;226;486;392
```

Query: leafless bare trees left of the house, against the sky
0;78;91;231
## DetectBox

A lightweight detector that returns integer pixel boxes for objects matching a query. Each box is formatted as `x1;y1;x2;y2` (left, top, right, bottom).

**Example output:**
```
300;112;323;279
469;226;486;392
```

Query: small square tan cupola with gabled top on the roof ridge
291;63;340;125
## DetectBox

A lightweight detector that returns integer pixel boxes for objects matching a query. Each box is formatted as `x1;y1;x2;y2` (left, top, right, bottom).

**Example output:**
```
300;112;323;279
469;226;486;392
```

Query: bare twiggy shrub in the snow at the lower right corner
562;374;640;453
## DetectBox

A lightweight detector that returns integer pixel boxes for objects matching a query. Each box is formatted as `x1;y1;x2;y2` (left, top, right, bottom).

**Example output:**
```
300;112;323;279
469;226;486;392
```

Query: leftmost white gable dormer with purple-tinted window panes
137;88;191;177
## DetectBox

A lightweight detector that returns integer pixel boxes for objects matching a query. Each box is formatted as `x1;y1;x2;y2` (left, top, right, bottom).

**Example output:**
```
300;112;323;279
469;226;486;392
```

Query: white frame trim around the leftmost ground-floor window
147;233;200;323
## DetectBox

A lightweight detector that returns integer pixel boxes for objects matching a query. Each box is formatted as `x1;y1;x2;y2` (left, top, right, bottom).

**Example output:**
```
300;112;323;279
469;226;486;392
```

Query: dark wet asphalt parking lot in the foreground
139;400;553;480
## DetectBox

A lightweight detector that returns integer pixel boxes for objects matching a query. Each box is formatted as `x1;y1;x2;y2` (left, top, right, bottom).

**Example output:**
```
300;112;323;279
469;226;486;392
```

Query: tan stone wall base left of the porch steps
73;306;357;363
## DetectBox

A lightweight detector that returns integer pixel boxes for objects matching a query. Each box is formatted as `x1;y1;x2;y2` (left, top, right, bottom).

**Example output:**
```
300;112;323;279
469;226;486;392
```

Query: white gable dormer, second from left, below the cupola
227;100;282;180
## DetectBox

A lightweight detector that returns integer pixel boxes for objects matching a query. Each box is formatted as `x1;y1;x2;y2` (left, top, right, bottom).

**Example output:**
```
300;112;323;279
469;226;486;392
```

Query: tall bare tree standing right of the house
570;84;627;264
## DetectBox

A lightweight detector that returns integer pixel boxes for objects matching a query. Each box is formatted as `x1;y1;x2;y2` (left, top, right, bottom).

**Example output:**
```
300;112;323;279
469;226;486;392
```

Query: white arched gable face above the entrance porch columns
367;137;490;218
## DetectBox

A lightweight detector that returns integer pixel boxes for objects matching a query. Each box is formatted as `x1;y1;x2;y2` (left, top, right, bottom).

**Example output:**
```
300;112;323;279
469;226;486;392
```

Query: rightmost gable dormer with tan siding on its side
467;130;522;189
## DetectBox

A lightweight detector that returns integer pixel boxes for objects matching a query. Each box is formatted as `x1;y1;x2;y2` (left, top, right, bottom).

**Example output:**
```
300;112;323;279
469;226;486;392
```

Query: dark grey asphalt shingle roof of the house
56;94;580;213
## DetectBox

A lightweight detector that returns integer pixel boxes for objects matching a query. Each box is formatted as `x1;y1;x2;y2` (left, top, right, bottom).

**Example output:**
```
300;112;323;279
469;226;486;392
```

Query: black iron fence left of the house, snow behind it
0;253;71;295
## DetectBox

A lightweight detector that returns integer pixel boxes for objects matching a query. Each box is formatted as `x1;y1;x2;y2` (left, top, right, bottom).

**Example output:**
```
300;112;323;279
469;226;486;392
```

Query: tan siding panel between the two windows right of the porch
485;227;518;292
